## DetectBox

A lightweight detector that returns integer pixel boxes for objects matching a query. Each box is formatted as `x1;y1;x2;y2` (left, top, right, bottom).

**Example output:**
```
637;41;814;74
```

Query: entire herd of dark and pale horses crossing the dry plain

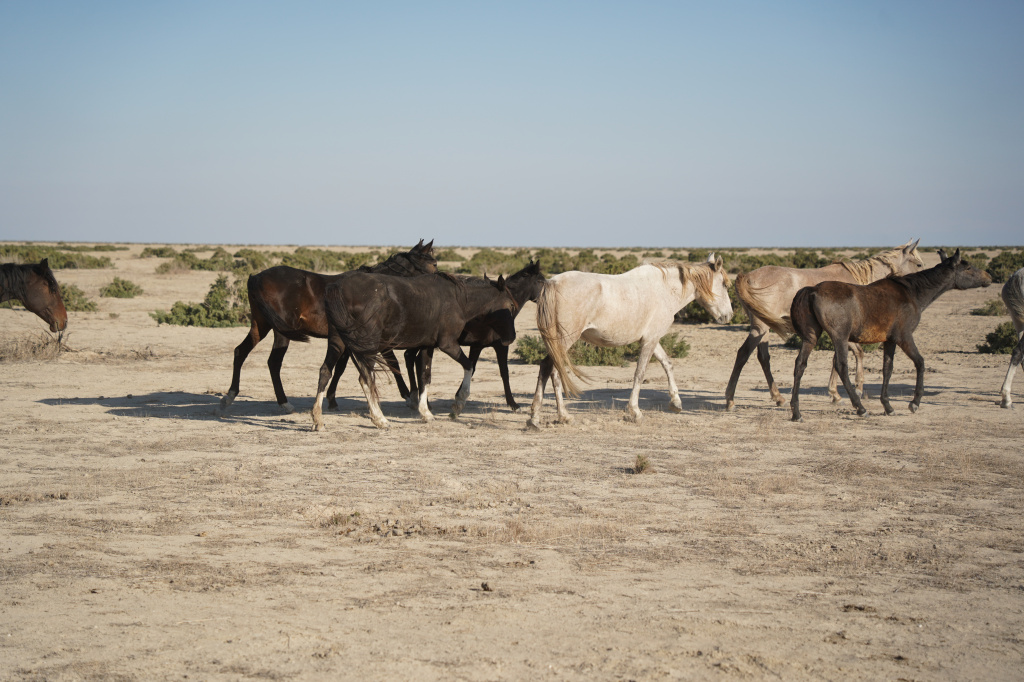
6;240;1024;430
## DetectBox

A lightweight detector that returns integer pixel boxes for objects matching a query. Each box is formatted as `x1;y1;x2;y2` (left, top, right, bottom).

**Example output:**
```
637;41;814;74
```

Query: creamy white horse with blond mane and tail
526;254;732;429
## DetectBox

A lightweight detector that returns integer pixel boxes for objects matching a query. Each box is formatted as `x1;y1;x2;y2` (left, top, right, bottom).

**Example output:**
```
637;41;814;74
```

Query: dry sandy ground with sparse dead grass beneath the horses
0;246;1024;680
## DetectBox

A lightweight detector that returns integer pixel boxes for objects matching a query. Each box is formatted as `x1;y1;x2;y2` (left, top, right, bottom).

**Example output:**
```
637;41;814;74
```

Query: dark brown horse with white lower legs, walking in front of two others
312;272;518;431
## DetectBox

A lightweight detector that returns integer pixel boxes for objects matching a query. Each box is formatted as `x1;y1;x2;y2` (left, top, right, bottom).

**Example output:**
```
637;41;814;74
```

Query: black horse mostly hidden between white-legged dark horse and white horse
406;261;545;419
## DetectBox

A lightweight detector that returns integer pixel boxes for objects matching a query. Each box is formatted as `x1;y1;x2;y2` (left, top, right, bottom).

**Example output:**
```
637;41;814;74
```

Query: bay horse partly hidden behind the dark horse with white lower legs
220;240;437;414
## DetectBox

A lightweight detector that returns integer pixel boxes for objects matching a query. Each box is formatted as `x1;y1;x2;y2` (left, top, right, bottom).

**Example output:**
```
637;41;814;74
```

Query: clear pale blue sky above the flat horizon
0;0;1024;247
